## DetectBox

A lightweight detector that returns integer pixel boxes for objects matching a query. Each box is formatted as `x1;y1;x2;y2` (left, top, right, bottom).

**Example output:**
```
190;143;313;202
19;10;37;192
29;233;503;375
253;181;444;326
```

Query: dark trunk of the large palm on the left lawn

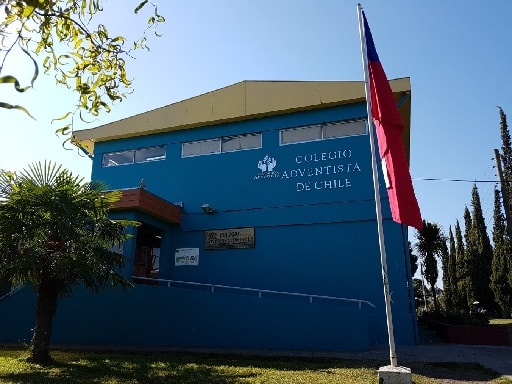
30;280;59;364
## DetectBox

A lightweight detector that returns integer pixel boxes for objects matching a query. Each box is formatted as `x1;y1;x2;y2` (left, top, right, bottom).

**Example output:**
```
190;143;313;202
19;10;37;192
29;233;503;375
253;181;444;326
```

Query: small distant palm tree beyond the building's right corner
415;220;446;312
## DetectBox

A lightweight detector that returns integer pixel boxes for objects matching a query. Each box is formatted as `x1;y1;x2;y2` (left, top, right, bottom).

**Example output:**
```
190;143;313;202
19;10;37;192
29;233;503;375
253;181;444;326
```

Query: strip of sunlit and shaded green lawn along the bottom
0;348;512;384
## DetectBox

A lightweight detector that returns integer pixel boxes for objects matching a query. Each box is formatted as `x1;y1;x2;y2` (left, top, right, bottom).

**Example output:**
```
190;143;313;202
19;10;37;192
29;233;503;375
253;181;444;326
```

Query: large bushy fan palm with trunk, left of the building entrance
0;162;134;364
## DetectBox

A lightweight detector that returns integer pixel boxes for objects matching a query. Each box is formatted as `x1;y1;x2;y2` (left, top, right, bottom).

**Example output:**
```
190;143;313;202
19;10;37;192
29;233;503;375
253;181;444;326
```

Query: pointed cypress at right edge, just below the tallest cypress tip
491;188;512;318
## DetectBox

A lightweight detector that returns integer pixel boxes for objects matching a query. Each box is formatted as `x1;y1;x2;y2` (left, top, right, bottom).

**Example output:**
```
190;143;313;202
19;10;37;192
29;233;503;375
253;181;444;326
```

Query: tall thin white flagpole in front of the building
357;4;398;367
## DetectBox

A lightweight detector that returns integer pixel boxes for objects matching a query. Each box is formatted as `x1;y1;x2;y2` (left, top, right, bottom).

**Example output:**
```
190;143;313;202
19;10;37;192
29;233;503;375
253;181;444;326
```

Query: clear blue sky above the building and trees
0;0;512;249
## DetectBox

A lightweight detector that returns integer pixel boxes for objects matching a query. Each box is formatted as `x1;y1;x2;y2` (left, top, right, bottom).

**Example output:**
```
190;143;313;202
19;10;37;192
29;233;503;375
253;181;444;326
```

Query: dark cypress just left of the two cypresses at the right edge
466;184;496;309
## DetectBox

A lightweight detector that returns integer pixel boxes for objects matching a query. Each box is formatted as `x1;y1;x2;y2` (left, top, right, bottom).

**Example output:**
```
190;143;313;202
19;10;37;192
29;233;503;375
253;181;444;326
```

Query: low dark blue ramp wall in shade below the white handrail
0;285;369;351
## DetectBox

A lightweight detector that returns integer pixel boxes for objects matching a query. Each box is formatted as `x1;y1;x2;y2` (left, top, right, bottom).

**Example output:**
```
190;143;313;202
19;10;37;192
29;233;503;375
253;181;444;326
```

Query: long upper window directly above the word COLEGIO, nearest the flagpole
280;120;366;145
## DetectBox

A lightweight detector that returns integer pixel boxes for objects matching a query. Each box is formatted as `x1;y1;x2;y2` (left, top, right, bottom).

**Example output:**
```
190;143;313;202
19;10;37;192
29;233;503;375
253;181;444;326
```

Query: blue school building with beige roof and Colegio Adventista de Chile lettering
0;78;418;351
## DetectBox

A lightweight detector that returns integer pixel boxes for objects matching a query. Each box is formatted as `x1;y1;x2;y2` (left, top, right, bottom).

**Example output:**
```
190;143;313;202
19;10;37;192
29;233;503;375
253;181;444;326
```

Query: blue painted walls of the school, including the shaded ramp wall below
0;104;416;350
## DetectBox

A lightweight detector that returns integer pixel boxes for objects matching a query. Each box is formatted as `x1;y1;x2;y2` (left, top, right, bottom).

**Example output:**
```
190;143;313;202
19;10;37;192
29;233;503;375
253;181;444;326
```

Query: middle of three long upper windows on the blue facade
181;133;261;157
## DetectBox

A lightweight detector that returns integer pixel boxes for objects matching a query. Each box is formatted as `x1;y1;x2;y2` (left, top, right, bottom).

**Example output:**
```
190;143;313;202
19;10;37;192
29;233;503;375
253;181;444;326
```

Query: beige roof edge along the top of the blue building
73;78;411;154
